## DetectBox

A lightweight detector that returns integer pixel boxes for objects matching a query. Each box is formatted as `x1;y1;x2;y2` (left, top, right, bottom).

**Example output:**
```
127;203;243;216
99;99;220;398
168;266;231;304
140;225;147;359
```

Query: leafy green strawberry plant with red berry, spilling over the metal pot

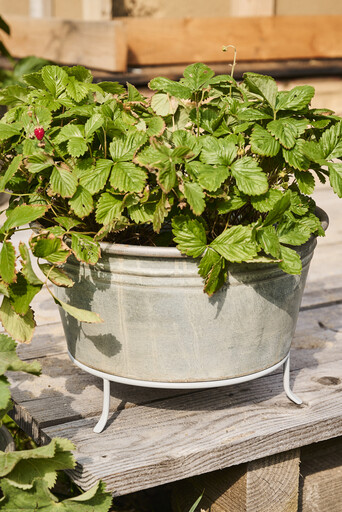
0;63;342;360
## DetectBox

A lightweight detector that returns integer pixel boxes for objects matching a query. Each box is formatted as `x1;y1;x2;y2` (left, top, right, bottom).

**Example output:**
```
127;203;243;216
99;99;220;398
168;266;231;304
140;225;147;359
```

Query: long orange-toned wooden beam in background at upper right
122;16;342;66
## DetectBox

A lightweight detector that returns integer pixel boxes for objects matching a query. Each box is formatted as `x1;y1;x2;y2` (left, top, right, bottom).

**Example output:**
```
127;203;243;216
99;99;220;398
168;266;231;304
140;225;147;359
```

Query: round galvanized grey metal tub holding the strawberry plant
57;208;326;380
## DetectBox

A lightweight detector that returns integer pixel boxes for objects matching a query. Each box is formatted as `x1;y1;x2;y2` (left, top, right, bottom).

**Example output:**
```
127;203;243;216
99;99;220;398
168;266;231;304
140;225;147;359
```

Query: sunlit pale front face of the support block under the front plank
246;449;300;512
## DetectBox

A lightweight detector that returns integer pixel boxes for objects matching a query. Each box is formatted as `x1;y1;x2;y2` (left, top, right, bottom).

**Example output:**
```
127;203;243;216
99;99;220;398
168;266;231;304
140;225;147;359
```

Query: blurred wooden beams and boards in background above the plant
0;0;342;72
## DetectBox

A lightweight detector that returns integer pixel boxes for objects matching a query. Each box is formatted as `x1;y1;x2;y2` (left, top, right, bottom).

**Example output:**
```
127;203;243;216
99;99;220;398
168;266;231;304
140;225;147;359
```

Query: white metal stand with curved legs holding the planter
68;352;303;433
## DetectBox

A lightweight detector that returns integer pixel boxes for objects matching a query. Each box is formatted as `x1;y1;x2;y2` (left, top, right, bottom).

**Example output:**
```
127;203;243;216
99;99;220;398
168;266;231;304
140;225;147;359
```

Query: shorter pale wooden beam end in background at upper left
4;16;127;71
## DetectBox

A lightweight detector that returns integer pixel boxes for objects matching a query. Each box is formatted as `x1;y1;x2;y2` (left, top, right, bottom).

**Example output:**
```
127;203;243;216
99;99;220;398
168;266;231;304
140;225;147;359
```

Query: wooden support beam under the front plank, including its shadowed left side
172;449;300;512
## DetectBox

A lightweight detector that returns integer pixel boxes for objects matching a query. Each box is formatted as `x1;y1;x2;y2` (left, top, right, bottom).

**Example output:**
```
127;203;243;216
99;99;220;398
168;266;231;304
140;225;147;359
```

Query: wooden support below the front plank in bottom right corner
300;438;342;512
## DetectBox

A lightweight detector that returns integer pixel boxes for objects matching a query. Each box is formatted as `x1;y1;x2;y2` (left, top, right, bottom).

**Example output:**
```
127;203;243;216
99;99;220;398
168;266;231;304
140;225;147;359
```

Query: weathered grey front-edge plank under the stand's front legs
31;360;342;494
